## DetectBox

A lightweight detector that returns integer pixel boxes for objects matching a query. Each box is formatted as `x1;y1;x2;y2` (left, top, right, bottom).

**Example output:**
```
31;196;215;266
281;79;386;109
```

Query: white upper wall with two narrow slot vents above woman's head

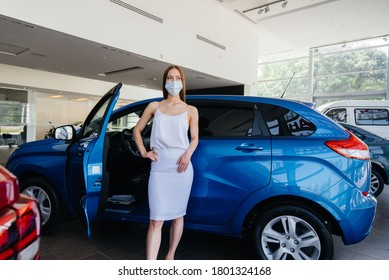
0;0;258;93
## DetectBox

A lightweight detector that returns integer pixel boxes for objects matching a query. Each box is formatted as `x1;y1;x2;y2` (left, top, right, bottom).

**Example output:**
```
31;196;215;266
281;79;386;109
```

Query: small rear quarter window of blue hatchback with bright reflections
259;104;316;136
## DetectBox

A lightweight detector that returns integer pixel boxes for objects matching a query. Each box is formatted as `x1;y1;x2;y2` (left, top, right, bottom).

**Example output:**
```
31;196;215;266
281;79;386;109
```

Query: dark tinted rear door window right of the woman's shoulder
196;106;254;137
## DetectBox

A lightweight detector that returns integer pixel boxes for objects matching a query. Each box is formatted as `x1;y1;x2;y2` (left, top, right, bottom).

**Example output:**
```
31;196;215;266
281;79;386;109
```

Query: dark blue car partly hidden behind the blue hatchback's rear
339;123;389;197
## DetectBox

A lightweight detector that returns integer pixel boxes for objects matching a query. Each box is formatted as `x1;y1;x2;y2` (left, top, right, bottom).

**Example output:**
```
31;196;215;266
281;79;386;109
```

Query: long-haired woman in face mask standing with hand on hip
133;65;199;260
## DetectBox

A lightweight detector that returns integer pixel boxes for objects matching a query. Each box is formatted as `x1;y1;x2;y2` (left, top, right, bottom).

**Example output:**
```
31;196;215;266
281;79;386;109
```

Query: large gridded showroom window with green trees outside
258;37;389;105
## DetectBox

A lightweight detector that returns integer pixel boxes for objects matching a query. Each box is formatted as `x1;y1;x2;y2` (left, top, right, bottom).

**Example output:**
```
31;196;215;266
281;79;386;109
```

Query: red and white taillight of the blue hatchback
325;132;370;160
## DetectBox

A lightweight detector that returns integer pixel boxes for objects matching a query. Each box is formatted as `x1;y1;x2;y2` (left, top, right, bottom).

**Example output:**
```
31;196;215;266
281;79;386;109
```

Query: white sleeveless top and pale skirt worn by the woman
149;105;193;221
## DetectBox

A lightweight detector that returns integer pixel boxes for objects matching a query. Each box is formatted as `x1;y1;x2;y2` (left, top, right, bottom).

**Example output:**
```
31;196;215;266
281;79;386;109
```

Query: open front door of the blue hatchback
73;83;122;236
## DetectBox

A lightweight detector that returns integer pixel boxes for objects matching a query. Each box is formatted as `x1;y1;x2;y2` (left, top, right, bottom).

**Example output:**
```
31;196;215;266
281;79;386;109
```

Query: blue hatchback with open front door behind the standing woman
7;84;376;259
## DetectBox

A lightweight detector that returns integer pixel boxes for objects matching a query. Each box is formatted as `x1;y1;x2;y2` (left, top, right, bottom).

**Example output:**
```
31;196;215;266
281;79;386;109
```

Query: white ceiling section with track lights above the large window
220;0;389;55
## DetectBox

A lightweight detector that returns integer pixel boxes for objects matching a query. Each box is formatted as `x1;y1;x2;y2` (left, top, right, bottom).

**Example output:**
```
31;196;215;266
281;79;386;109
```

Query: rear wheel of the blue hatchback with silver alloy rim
251;205;334;260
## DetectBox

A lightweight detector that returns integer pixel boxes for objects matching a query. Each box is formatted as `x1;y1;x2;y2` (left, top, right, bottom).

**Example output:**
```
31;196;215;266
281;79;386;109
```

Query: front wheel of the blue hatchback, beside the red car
20;178;59;233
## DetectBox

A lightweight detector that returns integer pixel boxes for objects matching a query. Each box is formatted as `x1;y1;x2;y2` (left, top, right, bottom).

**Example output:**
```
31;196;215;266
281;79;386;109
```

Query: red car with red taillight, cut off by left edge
0;165;41;260
